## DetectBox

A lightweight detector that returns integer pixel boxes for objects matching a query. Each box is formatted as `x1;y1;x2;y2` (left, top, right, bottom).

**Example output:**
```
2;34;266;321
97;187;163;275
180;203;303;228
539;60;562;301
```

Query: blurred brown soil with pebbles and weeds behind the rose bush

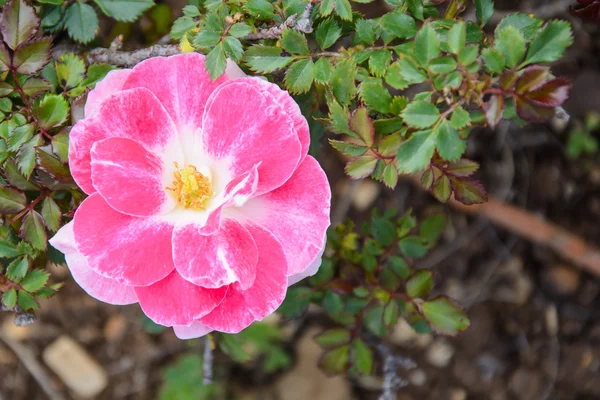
0;0;600;400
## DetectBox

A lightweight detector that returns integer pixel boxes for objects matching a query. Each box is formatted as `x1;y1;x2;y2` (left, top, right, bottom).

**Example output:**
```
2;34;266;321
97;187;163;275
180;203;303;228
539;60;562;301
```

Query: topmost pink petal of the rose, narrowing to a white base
124;53;227;128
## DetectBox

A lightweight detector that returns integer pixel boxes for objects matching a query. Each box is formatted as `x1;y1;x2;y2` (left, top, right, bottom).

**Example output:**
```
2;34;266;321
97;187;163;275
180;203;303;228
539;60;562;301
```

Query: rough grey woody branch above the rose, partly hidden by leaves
87;3;313;67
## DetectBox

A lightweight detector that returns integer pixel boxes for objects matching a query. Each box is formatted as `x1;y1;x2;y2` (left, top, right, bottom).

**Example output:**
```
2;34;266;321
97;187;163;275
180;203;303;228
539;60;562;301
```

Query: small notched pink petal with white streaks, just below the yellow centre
173;219;258;289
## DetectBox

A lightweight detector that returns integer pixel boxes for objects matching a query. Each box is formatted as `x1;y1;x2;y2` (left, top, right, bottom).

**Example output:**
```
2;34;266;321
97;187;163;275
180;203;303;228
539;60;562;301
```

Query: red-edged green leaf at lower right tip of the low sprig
421;297;471;335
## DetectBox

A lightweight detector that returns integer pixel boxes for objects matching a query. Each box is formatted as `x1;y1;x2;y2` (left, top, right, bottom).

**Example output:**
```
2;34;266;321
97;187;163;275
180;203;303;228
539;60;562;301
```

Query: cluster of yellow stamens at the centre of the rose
167;162;211;210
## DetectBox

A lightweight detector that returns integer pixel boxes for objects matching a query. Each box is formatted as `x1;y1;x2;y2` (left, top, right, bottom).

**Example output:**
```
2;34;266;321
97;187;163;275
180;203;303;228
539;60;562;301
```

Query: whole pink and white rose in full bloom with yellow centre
51;53;331;338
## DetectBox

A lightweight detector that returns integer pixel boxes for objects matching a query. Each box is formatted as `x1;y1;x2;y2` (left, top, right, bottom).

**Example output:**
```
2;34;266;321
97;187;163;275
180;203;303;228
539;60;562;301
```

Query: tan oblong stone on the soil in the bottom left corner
42;335;108;398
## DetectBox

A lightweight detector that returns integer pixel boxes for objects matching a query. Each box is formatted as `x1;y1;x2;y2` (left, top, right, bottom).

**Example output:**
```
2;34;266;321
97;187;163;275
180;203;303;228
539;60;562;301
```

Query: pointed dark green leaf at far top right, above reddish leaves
524;20;573;65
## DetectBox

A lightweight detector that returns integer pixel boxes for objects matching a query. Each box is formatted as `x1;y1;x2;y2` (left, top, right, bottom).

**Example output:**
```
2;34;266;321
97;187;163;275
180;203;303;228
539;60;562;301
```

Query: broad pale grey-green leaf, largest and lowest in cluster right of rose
396;130;436;173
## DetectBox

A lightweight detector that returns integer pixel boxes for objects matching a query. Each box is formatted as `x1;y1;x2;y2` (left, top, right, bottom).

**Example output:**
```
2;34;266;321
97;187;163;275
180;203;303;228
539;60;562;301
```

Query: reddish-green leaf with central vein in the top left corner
0;0;40;50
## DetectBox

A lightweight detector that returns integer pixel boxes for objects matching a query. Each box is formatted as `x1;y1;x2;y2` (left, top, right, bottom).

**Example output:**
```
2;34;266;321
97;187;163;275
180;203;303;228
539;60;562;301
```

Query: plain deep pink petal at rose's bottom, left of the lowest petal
135;271;227;326
